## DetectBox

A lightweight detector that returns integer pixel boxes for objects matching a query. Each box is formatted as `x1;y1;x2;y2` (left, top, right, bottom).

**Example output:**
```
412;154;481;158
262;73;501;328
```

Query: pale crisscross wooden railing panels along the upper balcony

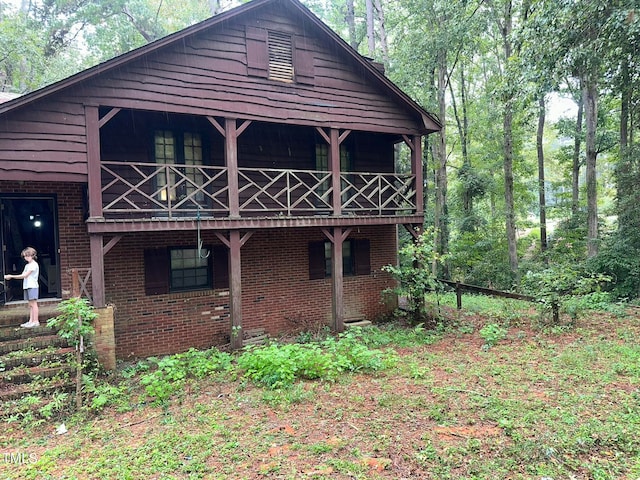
101;161;416;219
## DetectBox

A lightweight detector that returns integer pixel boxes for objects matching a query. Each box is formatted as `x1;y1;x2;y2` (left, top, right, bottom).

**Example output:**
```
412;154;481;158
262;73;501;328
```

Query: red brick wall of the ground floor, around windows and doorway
0;181;397;359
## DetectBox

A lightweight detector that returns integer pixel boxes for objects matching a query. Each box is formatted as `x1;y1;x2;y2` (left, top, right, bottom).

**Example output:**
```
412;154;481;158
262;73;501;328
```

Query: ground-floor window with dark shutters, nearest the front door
144;246;229;295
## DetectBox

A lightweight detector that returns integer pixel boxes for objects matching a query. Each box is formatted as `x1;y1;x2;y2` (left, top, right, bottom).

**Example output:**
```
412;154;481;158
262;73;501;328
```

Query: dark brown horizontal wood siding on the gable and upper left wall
0;2;423;181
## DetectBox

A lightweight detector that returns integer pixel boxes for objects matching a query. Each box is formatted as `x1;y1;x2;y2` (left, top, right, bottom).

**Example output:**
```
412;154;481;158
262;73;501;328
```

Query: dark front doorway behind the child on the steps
0;195;60;304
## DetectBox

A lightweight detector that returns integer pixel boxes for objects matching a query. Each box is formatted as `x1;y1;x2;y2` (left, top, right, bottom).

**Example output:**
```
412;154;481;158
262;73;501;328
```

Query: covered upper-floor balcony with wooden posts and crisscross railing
88;109;422;233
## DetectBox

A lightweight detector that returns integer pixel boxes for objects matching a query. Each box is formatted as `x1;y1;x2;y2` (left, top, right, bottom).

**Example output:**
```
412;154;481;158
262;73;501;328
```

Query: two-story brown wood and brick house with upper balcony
0;0;440;358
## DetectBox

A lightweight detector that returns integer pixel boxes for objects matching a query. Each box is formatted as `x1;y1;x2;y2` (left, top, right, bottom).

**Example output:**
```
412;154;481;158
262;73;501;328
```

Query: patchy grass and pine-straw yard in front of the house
0;300;640;480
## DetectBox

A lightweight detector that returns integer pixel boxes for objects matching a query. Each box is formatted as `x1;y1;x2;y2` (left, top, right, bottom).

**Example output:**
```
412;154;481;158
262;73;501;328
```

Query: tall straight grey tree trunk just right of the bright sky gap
583;74;598;258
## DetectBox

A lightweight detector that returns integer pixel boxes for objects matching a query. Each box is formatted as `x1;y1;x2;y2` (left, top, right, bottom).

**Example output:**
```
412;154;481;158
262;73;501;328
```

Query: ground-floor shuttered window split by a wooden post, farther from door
309;239;371;280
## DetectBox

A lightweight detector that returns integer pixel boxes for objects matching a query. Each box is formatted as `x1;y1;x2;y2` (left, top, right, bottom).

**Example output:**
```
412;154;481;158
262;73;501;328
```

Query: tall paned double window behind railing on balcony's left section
154;130;204;202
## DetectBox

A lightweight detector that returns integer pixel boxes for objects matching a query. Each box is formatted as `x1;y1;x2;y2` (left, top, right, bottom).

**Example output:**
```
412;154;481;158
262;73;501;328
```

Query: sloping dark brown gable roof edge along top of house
0;0;441;133
